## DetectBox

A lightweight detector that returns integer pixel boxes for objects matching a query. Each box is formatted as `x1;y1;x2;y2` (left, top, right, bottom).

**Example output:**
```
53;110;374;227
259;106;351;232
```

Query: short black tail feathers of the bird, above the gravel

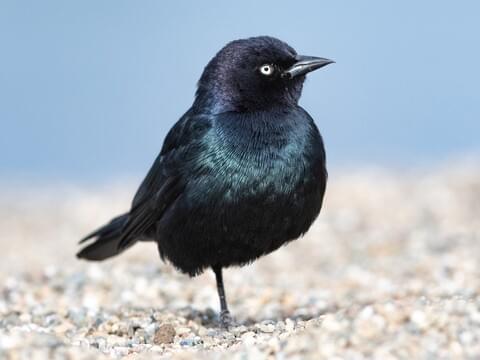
77;213;132;261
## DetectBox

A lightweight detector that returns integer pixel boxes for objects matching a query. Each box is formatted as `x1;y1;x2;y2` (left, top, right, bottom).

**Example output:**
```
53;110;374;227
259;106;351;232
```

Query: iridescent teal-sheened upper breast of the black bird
187;109;323;203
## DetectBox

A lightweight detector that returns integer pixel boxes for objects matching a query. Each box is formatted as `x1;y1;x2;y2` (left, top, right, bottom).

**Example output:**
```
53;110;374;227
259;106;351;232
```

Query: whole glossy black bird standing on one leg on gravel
77;36;332;325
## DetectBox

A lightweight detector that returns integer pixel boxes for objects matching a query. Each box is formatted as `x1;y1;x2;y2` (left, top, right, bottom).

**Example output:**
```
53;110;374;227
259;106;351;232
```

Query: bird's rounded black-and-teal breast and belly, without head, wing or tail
154;108;325;275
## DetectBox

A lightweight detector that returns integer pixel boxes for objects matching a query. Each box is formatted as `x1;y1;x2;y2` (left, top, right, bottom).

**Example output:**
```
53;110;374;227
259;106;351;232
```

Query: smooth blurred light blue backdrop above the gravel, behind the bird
0;0;480;182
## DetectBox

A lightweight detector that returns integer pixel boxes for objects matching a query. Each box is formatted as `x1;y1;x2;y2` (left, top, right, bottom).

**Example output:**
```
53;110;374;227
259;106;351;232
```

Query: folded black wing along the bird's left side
118;113;208;249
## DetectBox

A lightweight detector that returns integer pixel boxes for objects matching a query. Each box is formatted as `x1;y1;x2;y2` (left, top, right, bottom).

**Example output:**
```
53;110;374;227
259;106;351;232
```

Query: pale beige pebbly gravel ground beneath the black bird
0;164;480;360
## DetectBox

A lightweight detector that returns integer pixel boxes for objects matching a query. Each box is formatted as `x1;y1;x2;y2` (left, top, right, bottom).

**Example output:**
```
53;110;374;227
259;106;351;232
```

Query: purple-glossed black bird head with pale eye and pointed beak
195;36;333;113
